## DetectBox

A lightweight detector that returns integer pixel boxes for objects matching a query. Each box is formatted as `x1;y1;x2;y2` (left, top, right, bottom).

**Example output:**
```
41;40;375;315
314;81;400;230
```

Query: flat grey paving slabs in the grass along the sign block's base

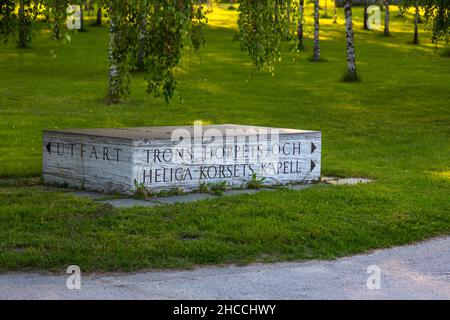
70;177;372;208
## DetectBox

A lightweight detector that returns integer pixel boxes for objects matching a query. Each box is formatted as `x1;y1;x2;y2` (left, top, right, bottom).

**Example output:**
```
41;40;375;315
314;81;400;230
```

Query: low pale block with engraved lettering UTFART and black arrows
42;124;322;194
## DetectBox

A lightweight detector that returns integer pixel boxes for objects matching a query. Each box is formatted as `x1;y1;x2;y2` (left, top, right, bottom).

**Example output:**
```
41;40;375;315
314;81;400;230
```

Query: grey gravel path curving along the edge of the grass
0;237;450;299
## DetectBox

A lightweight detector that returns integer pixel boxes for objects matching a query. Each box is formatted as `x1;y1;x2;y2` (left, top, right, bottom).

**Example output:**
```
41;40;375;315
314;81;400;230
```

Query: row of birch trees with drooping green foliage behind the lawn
0;0;450;103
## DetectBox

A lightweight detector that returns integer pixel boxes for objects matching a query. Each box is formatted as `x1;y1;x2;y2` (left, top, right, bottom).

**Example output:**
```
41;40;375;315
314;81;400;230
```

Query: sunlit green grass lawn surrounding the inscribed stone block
0;4;450;271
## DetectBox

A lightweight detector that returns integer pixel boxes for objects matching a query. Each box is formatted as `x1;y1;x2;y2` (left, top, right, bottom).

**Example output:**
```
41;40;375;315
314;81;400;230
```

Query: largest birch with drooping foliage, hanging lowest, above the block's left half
108;0;206;103
